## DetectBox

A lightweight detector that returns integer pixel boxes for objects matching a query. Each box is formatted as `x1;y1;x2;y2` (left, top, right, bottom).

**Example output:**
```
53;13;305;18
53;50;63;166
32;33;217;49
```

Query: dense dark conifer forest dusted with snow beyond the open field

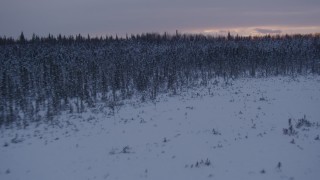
0;33;320;126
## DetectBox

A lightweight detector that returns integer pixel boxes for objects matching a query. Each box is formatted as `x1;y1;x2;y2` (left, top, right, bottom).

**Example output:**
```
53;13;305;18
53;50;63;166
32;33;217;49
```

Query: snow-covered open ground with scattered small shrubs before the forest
0;76;320;180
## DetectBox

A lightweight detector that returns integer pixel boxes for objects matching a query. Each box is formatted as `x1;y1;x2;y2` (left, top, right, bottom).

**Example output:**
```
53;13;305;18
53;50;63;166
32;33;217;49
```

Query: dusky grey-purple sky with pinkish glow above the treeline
0;0;320;37
